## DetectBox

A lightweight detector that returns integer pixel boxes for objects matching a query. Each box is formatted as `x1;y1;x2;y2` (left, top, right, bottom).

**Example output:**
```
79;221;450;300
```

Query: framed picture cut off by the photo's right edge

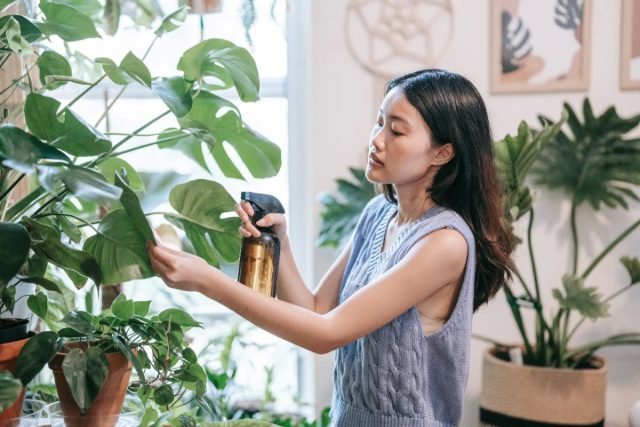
620;0;640;89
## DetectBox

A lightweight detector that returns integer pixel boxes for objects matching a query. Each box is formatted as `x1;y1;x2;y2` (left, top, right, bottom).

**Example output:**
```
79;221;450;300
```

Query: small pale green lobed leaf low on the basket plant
552;274;609;320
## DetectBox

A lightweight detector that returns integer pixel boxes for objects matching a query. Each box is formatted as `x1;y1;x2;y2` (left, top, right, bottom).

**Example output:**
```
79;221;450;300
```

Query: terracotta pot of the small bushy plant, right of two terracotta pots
49;345;131;427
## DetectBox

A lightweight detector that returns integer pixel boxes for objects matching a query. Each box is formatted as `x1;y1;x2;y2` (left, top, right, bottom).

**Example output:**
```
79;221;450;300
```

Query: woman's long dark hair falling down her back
383;69;515;312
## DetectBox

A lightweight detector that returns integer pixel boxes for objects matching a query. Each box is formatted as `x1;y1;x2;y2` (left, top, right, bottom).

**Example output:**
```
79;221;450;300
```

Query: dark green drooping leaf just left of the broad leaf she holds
24;218;100;283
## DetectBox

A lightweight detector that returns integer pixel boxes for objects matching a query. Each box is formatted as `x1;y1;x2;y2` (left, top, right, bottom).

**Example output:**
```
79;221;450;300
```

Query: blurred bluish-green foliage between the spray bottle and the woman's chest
316;168;375;248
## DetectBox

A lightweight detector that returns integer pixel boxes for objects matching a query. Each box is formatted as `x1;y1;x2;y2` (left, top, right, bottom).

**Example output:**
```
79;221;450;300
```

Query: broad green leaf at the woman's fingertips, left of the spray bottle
84;209;155;284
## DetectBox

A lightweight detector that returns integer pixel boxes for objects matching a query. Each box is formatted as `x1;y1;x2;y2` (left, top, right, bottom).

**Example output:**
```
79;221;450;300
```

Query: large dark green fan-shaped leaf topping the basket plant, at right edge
532;98;640;210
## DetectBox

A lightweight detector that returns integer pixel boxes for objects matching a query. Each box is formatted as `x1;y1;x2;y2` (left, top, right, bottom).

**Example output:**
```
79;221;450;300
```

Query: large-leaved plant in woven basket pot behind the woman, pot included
478;99;640;425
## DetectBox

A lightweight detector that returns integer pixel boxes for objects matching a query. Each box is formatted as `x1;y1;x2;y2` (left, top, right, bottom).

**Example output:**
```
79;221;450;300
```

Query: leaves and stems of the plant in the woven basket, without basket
496;99;640;368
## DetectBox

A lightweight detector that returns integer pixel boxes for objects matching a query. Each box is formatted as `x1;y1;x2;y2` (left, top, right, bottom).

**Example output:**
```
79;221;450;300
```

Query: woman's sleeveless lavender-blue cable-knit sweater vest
331;196;476;427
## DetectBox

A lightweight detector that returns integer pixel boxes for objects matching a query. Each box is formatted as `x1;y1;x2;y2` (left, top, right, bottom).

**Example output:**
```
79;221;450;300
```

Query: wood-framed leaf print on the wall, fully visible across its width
491;0;592;93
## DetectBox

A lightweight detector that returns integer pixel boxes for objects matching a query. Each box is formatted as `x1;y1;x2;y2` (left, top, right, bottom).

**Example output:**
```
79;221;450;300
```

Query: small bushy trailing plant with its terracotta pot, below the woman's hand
49;294;206;427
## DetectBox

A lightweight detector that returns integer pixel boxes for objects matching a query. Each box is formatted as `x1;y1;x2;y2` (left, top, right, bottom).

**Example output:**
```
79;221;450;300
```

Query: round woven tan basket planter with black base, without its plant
480;348;607;427
